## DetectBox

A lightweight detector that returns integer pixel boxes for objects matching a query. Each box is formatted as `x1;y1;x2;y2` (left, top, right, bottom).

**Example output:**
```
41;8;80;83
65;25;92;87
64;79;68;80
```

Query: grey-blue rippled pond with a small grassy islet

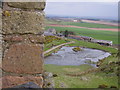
44;46;111;66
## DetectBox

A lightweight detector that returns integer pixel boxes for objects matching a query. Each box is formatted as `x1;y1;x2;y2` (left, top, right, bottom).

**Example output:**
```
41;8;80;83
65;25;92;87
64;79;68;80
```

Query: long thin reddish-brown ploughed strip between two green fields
47;24;118;31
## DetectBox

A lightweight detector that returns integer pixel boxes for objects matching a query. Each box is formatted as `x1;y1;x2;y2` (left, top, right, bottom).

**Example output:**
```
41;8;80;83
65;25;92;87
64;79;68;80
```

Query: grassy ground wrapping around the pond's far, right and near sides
45;39;118;88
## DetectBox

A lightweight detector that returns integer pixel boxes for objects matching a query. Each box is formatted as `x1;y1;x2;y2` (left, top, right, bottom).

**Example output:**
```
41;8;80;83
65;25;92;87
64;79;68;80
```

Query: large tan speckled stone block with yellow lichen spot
2;11;44;34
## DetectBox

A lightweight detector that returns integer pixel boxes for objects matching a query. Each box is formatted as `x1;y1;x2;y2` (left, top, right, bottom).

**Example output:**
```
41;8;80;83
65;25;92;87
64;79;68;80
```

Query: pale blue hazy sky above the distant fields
45;0;118;20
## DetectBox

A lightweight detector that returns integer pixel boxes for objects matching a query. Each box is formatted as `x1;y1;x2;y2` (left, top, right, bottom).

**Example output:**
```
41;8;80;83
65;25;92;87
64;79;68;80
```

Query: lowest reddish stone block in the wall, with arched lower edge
2;76;43;88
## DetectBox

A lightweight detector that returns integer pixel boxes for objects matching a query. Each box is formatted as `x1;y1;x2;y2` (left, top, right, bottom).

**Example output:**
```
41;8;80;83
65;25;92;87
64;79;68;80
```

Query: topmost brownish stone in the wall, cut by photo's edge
8;0;45;10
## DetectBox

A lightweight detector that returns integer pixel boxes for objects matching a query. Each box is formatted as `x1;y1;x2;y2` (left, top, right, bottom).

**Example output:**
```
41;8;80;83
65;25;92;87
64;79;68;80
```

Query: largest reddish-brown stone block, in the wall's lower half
2;44;43;74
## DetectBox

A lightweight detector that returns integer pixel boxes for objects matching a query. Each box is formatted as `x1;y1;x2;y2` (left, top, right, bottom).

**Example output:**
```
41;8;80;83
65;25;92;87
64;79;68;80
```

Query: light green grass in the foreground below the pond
45;65;118;88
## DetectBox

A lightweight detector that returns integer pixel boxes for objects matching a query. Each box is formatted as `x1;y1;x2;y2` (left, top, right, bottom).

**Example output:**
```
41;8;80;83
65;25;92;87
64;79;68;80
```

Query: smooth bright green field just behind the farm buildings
46;26;118;44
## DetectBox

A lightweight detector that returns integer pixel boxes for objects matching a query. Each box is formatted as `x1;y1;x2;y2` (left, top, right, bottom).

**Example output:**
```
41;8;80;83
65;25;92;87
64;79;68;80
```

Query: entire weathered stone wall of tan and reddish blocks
1;2;45;88
